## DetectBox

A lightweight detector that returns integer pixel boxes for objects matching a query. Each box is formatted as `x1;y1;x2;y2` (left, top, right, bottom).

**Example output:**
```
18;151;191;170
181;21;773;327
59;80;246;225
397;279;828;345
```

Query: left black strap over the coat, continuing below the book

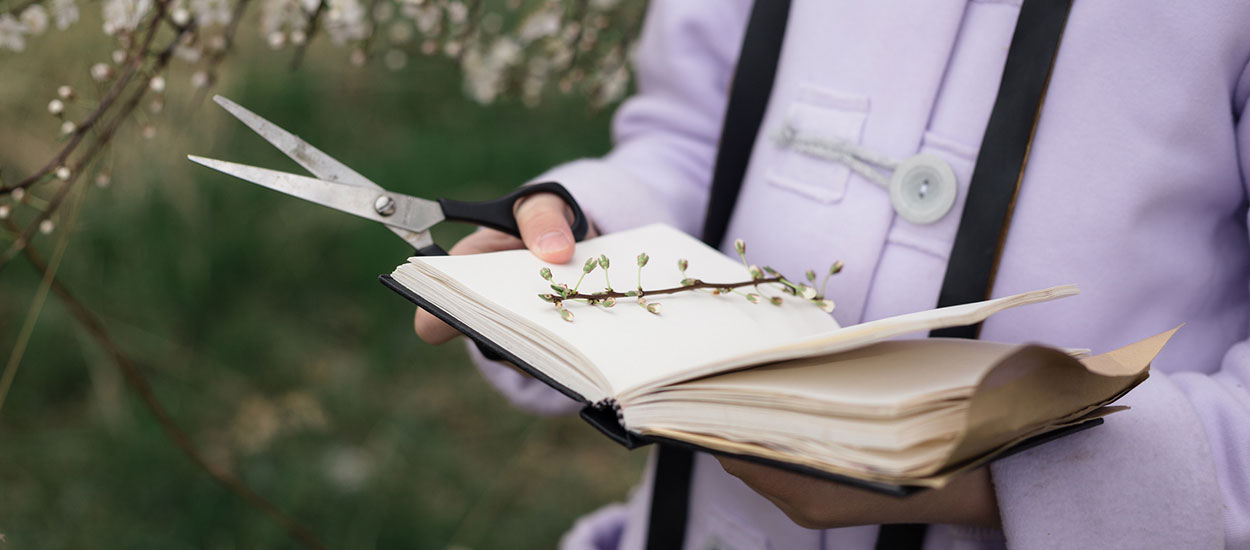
646;0;790;550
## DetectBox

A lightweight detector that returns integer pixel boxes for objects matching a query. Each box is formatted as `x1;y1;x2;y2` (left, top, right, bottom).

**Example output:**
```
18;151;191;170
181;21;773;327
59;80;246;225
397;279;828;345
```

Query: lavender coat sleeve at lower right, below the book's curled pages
993;68;1250;550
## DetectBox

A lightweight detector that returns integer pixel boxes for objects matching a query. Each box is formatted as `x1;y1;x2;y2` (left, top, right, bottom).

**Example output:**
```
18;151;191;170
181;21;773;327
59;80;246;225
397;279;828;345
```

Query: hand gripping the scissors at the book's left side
413;193;595;344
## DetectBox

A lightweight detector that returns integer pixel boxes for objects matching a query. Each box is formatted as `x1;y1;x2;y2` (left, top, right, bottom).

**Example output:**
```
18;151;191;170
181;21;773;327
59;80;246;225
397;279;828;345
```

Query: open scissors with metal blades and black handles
186;95;589;256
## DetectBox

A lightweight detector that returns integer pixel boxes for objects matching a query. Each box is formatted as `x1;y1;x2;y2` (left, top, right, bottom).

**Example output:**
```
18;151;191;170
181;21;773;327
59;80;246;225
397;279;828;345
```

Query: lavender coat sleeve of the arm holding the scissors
469;0;751;415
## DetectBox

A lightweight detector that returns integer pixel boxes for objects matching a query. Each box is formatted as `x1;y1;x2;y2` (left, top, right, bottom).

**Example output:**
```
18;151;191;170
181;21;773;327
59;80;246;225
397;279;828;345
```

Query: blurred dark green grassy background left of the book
0;15;645;549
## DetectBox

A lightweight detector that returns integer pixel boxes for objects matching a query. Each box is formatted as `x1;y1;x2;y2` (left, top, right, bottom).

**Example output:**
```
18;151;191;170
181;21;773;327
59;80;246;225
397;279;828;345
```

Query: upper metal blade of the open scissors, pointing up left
213;95;434;249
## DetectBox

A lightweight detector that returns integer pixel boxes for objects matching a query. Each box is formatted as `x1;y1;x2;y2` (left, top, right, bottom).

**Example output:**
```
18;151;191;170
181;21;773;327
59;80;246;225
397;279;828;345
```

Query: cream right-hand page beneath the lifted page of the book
671;339;1020;411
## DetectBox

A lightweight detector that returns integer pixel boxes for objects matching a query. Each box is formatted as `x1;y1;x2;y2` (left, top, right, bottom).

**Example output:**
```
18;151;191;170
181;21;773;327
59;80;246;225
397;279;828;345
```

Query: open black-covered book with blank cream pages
383;225;1171;493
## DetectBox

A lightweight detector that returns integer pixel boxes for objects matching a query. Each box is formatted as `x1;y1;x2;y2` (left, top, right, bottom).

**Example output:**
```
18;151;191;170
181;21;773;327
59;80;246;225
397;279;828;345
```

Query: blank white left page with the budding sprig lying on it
410;224;838;394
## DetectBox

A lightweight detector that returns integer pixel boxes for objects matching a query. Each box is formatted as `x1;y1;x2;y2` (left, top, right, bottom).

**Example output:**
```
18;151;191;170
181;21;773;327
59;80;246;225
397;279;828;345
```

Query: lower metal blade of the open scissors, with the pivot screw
186;155;444;233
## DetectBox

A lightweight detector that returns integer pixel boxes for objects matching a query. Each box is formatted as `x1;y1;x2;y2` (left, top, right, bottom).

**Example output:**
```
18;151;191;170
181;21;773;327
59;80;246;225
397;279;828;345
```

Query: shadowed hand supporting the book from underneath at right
716;456;1001;529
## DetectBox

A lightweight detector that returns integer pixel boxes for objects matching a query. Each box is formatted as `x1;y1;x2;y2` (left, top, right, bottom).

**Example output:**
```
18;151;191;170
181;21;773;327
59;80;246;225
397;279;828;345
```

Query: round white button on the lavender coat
890;155;959;224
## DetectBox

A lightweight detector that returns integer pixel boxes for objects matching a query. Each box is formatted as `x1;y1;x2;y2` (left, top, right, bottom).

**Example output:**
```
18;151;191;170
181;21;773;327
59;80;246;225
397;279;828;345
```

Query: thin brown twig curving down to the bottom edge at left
5;220;325;549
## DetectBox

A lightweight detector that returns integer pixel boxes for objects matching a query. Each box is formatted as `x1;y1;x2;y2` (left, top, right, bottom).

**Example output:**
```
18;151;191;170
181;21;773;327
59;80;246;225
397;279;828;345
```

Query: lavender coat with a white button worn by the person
467;0;1250;550
